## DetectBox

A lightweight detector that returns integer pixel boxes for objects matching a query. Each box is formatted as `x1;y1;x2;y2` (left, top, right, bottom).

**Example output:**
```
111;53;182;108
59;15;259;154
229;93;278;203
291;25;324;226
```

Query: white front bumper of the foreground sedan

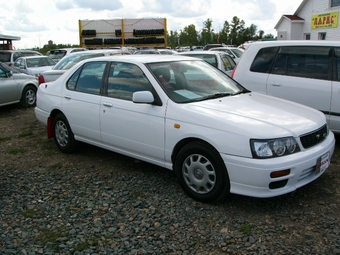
221;132;335;198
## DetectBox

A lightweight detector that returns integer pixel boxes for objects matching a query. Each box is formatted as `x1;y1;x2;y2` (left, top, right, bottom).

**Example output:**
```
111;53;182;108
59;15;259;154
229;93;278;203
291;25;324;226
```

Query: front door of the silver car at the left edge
0;65;21;105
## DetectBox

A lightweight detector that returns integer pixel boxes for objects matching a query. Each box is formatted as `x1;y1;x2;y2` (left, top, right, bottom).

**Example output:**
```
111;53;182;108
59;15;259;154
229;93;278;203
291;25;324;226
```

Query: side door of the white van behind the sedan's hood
266;46;332;120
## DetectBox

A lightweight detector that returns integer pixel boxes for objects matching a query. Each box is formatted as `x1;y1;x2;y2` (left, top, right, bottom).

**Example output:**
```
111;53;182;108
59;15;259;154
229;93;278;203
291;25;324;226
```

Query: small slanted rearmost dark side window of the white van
250;47;279;73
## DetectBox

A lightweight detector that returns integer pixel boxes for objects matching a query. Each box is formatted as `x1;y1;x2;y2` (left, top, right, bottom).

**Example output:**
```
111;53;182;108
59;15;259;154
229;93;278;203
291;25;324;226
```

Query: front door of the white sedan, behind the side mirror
100;62;165;163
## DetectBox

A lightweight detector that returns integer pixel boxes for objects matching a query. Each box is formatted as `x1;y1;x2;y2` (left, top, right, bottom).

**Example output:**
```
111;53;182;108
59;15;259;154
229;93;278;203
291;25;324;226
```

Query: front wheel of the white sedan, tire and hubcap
174;142;230;203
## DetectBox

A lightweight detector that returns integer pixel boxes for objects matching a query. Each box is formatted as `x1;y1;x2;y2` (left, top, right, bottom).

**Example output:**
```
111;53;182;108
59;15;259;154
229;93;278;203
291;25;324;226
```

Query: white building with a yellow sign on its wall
274;0;340;41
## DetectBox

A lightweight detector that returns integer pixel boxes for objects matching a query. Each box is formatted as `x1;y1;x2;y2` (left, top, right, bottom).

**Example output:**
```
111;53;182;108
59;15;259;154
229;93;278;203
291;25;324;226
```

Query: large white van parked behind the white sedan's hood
232;40;340;133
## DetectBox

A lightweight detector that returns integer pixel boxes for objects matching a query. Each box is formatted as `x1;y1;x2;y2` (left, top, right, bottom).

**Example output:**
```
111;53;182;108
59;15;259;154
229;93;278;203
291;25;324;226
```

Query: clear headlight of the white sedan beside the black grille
250;137;300;158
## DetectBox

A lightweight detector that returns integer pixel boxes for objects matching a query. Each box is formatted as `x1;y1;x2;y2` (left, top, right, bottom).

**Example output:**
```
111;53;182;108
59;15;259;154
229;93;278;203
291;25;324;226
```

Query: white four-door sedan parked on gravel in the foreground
35;55;335;202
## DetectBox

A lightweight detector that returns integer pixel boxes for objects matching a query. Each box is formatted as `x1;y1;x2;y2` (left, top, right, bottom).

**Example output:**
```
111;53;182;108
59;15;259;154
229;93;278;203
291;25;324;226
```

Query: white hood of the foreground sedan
167;92;326;138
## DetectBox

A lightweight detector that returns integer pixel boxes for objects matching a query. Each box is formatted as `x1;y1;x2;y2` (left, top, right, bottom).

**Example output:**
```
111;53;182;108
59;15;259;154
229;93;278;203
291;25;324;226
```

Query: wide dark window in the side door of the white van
272;46;331;80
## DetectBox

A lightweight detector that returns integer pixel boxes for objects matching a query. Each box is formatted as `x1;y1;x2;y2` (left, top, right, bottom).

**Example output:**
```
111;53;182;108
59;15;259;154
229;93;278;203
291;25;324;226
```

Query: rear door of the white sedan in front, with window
62;61;107;144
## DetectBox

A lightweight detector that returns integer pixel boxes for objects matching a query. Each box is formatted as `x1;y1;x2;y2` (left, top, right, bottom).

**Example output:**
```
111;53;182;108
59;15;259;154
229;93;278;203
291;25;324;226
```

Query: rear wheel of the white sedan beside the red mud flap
53;113;78;153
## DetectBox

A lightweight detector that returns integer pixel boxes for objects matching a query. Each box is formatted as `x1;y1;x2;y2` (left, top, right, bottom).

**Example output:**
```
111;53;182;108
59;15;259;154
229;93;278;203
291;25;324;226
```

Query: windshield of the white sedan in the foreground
147;60;249;103
